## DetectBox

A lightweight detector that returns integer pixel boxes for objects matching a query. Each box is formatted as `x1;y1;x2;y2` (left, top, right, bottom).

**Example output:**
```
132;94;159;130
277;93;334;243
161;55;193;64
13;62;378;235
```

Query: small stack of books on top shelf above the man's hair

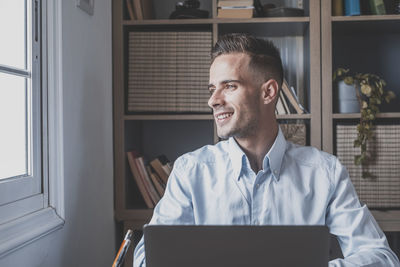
217;0;254;19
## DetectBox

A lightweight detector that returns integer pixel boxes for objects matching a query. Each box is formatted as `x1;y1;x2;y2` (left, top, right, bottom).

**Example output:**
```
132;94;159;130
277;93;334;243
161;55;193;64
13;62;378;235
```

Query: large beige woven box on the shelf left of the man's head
127;31;212;113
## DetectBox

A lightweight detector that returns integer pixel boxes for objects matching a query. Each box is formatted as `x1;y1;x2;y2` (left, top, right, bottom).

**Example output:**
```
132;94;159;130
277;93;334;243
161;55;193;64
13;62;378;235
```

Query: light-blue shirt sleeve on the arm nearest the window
133;158;194;267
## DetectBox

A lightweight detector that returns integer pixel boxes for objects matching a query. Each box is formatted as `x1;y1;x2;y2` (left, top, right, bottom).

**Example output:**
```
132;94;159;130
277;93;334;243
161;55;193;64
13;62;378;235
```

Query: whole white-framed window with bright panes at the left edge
0;0;63;257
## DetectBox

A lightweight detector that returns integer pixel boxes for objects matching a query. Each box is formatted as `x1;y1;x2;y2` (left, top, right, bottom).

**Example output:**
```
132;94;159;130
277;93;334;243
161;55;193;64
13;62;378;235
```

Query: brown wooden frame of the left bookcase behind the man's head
113;0;322;230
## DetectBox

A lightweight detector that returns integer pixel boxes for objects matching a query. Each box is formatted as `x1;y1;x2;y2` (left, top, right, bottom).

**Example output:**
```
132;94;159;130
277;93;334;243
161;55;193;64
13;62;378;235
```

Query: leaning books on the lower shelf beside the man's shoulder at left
127;151;172;209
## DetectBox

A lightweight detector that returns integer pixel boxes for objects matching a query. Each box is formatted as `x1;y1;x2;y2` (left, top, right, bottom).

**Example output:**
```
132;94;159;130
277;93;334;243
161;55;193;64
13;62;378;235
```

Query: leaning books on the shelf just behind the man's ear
275;80;305;115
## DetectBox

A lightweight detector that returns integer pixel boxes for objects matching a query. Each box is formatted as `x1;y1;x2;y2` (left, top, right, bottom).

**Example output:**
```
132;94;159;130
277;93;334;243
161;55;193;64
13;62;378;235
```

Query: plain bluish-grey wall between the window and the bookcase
0;0;115;267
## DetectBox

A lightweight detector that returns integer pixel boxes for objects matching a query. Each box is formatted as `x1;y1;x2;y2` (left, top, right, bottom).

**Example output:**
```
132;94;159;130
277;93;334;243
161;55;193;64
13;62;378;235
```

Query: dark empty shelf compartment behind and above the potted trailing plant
332;20;400;113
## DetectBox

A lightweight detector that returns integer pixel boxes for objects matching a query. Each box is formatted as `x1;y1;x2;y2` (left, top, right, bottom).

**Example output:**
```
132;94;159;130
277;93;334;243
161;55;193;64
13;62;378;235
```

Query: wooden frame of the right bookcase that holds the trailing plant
321;1;400;232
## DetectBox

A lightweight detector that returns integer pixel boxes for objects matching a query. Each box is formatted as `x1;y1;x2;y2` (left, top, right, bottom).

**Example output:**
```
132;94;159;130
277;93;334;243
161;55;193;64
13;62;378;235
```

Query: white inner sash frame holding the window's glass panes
0;0;41;220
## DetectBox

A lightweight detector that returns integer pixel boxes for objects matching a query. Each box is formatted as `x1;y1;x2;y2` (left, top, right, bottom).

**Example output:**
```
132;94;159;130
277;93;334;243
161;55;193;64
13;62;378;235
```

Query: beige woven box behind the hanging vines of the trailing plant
336;125;400;208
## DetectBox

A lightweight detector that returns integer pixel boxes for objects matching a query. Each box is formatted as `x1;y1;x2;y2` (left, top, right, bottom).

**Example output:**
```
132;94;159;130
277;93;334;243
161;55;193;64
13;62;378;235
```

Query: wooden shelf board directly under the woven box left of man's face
124;114;214;121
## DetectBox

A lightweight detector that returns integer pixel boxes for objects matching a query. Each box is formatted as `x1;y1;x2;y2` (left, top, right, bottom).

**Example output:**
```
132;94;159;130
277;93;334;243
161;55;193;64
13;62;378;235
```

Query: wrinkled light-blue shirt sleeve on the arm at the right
326;159;400;267
